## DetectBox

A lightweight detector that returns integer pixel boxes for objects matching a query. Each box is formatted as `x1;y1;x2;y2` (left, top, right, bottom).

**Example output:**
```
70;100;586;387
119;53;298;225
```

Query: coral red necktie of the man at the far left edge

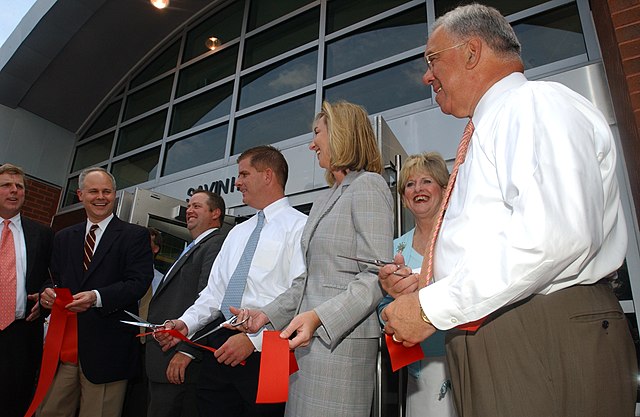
0;220;18;330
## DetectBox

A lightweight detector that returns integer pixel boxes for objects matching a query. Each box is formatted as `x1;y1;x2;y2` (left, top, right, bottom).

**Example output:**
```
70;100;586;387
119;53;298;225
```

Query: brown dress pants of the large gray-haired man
447;283;637;417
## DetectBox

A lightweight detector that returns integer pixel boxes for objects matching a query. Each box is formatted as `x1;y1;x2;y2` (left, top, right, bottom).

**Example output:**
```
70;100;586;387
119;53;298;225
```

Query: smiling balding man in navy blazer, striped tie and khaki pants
38;168;153;417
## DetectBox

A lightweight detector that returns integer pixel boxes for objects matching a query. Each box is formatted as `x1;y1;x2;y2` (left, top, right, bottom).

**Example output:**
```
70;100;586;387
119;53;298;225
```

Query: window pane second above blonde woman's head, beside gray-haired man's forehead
326;6;427;78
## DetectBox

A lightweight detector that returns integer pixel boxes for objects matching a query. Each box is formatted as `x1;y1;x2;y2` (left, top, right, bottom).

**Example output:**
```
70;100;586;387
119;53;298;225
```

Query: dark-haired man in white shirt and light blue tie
158;146;307;417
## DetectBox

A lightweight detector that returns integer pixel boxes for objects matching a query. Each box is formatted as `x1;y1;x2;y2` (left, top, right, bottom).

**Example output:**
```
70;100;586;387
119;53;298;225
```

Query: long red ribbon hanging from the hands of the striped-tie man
24;288;78;417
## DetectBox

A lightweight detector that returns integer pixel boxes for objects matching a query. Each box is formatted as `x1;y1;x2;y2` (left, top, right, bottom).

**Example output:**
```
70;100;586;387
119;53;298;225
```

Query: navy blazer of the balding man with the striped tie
51;216;153;384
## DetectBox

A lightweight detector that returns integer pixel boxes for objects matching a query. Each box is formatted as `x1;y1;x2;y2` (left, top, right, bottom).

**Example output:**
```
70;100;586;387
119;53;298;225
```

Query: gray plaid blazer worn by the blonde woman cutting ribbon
263;171;393;349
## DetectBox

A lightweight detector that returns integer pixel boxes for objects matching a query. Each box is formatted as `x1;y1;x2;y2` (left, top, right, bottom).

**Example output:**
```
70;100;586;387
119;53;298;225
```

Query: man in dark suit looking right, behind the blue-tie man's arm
146;190;226;417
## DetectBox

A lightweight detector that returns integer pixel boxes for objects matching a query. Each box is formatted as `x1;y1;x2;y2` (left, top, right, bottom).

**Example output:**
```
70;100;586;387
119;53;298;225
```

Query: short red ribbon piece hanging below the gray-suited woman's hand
256;330;298;404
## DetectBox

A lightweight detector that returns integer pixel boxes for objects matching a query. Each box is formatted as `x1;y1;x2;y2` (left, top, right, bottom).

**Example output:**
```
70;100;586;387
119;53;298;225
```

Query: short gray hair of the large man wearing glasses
433;3;522;60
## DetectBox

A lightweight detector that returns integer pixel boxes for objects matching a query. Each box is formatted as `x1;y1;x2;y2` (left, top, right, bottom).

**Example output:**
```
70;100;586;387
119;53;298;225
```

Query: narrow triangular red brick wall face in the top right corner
608;0;640;132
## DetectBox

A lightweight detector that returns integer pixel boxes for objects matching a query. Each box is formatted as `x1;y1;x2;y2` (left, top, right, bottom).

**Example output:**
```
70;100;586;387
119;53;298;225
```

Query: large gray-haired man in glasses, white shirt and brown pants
380;4;637;417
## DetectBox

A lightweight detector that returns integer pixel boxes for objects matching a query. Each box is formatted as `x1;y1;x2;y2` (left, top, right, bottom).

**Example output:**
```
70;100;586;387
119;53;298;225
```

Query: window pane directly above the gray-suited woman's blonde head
325;57;431;114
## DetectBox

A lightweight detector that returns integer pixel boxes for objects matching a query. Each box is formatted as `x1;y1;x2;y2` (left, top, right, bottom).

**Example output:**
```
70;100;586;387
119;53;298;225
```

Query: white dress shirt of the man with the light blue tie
180;197;307;351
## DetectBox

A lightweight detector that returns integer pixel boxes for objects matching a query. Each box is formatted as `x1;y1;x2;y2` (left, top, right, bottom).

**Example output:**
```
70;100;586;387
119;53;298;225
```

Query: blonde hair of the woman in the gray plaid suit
313;101;382;185
